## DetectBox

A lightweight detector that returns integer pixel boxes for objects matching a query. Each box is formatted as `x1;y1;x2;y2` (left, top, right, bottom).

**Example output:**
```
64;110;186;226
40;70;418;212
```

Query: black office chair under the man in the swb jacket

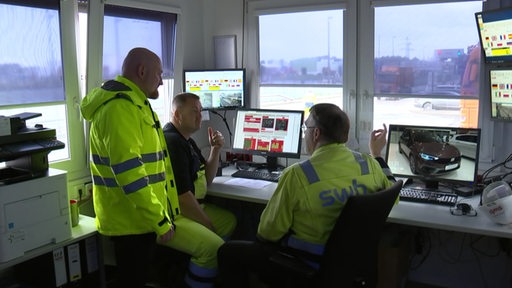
271;180;403;287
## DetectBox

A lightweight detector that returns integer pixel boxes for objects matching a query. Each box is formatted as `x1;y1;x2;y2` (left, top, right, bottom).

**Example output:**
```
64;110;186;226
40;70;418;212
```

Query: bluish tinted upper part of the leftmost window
0;1;65;107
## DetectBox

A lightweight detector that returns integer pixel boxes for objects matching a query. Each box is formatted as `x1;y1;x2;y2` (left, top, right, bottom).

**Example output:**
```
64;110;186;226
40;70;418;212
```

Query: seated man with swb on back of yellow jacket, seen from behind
218;103;393;287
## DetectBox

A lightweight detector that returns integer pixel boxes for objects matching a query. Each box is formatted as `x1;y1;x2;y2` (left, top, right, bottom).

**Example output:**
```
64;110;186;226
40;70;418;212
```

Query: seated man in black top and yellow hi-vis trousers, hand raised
163;93;237;287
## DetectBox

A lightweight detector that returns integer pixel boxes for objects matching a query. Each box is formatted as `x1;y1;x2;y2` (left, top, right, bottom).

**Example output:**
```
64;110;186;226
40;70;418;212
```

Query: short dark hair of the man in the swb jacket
309;103;350;143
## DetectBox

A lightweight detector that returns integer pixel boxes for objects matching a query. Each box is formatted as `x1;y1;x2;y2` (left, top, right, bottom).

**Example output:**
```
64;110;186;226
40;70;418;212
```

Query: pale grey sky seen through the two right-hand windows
260;1;482;60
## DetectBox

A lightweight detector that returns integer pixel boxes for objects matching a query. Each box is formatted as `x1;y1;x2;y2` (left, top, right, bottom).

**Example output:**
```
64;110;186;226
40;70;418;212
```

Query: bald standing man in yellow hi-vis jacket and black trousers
80;48;180;287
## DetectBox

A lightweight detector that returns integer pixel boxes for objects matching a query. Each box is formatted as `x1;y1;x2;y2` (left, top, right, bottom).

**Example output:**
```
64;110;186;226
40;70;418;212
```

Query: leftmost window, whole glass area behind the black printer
0;1;70;161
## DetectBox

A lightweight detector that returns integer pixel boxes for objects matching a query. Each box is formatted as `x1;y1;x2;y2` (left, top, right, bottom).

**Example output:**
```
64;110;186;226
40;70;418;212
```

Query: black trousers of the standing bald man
110;233;156;288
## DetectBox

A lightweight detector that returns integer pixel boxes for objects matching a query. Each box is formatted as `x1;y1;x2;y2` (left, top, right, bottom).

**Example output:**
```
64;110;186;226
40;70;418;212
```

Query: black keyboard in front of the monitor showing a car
400;188;458;206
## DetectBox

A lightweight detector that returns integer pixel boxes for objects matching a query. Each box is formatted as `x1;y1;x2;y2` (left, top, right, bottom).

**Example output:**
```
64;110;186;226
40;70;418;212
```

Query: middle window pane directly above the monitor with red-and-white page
259;10;343;117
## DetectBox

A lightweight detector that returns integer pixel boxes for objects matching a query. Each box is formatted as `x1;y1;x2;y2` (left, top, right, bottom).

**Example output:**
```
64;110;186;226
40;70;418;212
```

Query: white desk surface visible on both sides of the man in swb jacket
208;167;512;238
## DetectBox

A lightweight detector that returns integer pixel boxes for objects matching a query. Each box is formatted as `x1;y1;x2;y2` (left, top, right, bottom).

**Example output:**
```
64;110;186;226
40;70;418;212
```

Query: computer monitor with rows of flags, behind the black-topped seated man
183;69;247;110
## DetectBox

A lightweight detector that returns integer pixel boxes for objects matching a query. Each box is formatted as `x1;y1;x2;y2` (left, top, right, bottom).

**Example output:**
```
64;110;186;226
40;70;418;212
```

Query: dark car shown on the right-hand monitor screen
398;129;461;175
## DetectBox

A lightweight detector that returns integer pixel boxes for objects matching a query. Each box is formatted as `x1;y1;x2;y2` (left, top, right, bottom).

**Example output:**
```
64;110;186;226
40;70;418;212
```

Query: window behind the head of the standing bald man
80;5;177;122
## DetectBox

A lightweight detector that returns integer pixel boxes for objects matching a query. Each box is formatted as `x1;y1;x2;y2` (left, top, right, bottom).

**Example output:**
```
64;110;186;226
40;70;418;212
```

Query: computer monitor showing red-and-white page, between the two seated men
232;109;304;171
